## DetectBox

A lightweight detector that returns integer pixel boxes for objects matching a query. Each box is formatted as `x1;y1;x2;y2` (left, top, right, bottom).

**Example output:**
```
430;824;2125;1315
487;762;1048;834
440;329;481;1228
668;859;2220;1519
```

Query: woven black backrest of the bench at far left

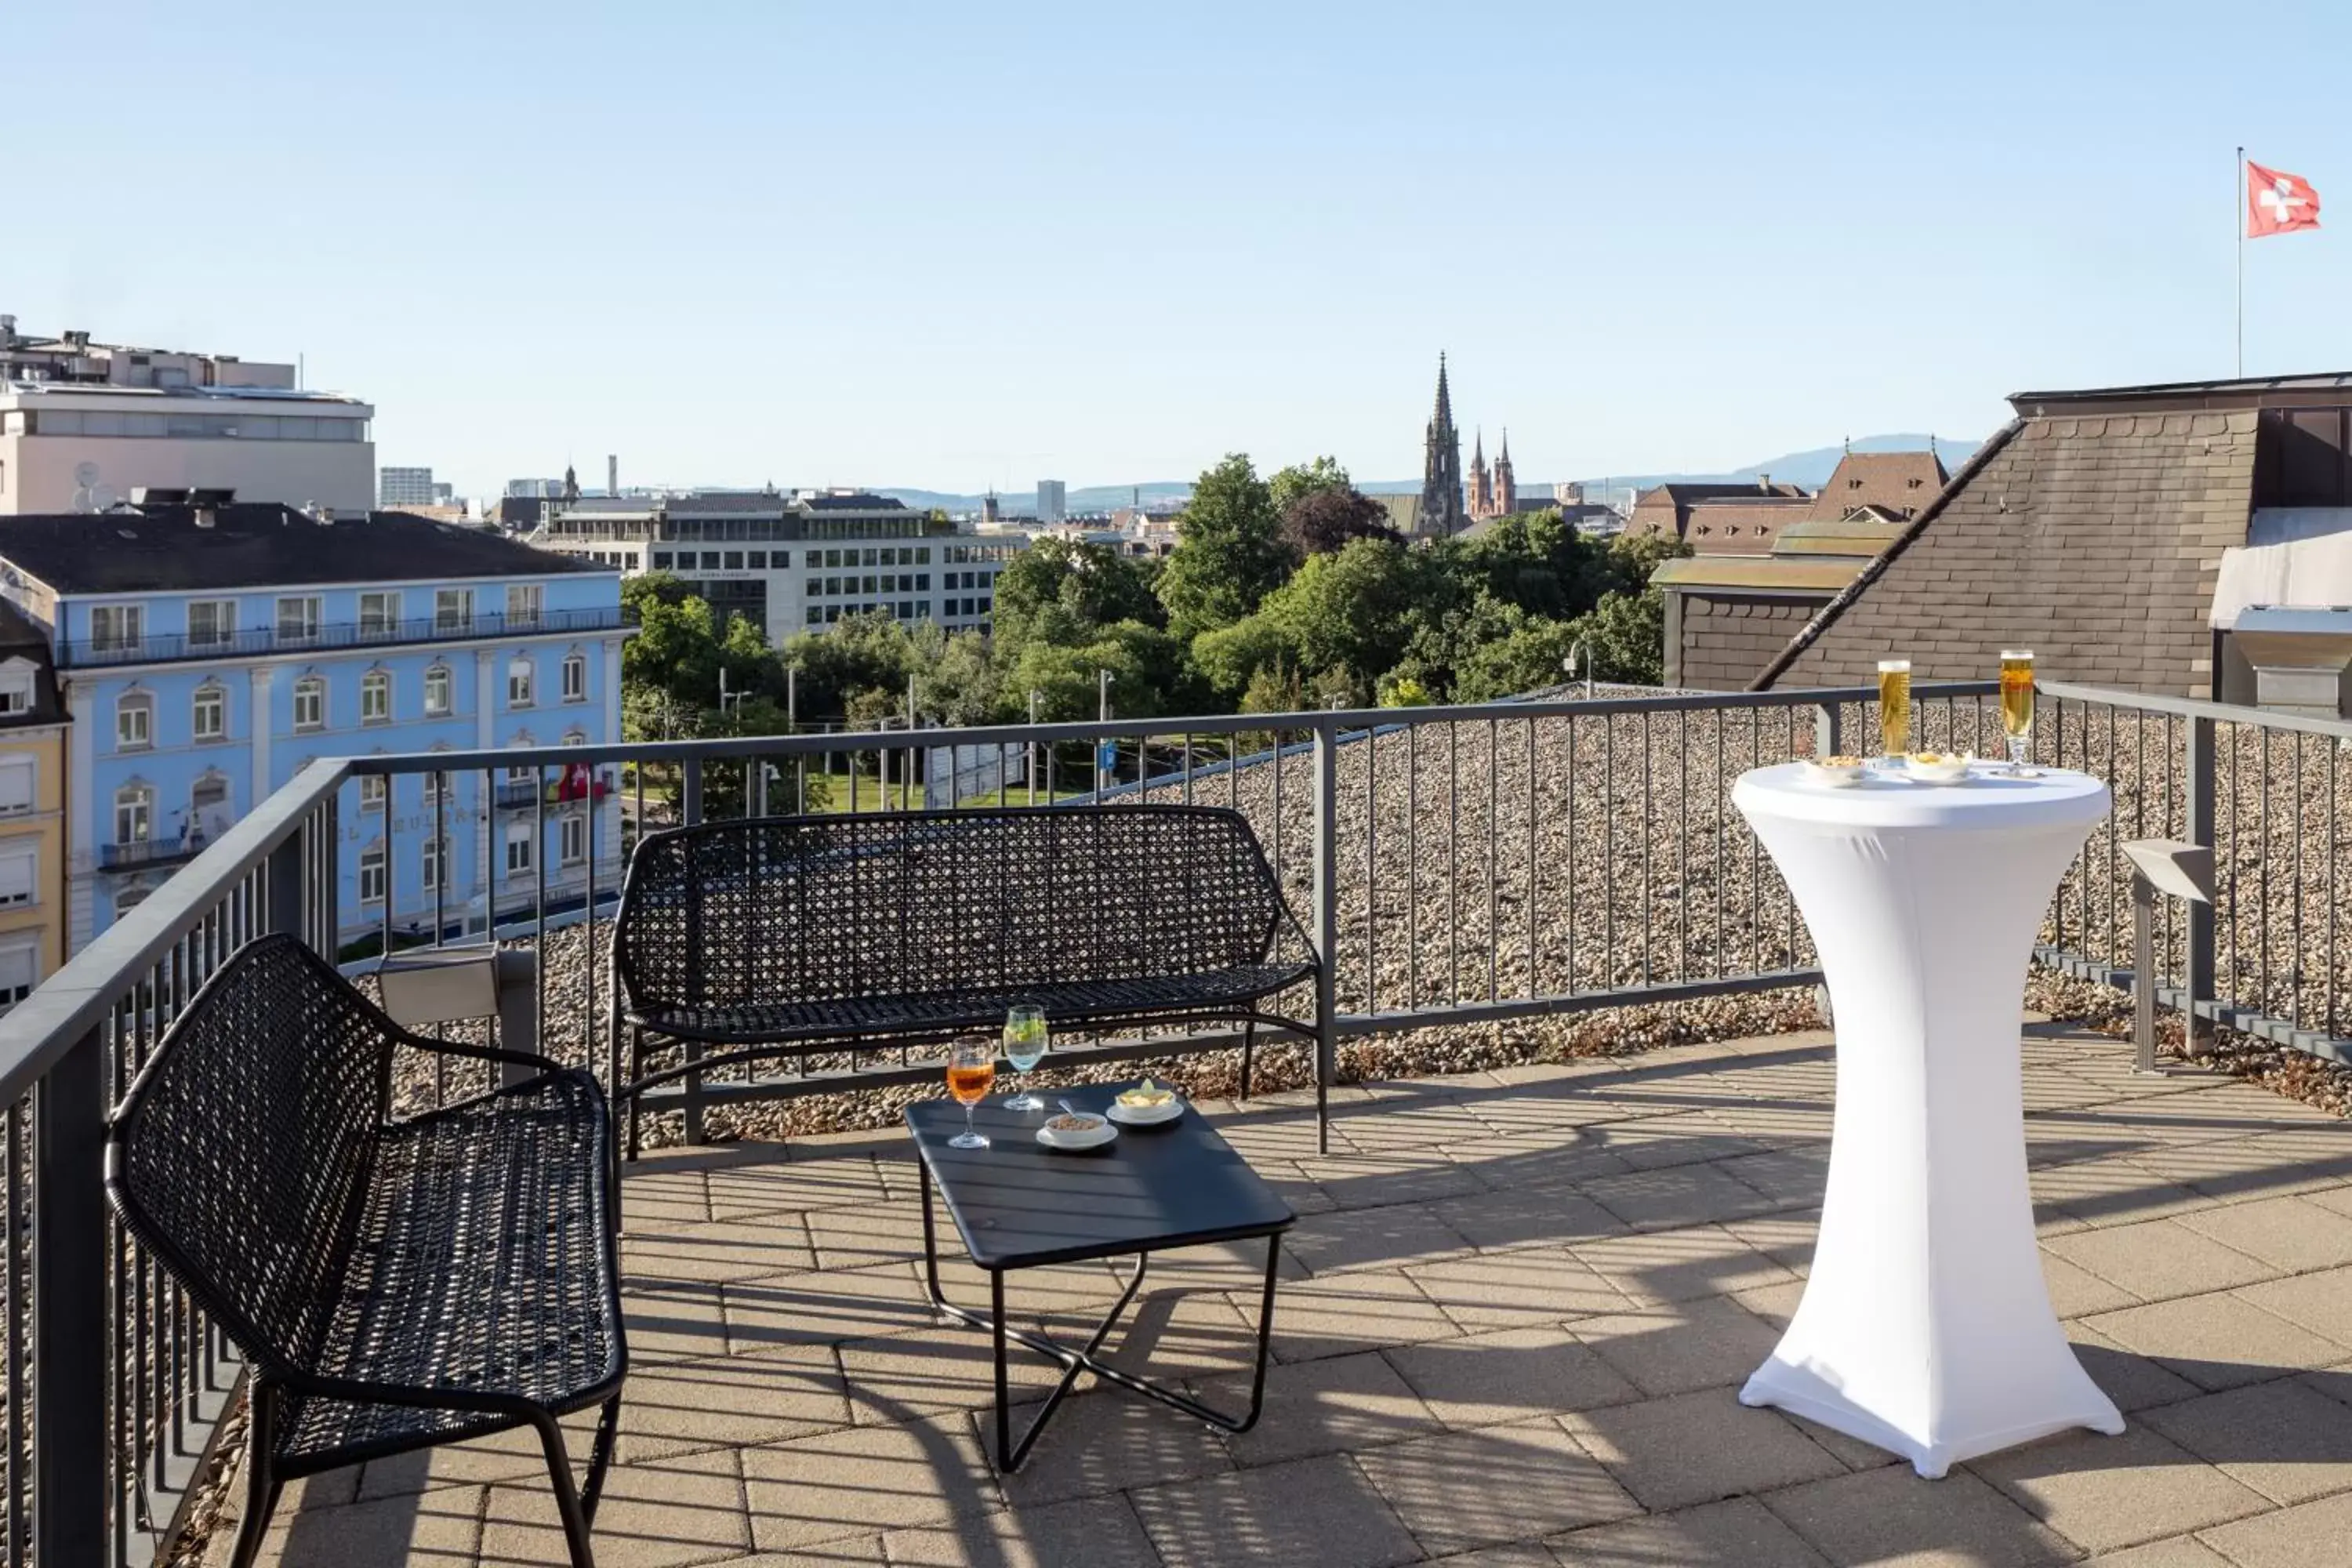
106;935;393;1373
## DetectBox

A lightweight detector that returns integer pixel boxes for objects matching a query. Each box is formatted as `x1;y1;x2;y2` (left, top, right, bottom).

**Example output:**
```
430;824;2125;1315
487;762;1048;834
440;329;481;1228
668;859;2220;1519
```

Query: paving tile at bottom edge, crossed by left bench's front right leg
482;1448;753;1568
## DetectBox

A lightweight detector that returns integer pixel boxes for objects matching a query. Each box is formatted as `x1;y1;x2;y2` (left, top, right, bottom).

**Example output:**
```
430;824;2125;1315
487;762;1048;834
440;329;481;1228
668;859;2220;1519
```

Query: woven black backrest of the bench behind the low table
616;806;1284;1006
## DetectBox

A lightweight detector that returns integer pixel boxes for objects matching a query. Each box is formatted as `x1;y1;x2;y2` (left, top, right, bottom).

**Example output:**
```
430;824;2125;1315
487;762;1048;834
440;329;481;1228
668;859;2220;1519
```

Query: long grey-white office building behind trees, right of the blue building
532;489;1028;644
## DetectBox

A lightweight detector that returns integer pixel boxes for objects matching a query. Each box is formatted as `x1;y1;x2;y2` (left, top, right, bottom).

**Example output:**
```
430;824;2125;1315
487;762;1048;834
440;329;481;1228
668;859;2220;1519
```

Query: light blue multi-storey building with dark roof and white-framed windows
0;492;623;949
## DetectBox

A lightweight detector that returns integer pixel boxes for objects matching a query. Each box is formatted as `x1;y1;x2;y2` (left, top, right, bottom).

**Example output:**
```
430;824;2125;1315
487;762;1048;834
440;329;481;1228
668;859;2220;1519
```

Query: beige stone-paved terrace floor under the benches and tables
229;1025;2352;1568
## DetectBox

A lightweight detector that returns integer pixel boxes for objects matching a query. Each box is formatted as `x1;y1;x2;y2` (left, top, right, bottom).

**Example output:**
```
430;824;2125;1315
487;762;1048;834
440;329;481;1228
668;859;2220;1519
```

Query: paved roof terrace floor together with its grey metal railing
13;682;2352;1568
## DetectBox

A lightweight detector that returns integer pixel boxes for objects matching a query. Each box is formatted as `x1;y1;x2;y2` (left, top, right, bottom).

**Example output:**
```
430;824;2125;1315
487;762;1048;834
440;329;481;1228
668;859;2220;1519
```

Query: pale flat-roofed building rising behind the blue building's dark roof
0;315;376;515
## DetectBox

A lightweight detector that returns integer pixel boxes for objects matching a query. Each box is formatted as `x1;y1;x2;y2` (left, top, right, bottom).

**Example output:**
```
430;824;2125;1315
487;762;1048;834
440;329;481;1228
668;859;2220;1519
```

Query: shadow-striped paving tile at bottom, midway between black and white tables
1355;1420;1642;1556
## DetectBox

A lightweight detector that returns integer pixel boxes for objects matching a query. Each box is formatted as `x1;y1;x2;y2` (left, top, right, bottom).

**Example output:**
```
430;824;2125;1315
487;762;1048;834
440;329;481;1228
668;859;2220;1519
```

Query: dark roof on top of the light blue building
0;503;614;593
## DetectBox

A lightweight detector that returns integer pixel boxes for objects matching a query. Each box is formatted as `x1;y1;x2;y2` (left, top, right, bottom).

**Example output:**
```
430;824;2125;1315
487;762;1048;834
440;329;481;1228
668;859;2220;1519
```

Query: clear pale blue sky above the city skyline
0;0;2352;492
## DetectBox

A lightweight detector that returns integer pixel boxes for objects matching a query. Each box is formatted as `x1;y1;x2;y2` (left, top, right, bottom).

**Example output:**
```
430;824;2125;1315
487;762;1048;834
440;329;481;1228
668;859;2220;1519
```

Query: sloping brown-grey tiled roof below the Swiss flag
1752;411;2258;696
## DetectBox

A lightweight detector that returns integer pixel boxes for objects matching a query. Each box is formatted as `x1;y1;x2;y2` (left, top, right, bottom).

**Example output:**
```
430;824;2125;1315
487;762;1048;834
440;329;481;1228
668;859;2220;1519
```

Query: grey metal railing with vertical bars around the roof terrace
13;682;2352;1568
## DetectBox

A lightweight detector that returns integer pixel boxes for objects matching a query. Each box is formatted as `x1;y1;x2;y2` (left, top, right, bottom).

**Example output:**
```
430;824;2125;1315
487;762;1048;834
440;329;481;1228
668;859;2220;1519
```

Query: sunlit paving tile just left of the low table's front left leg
743;1415;1002;1568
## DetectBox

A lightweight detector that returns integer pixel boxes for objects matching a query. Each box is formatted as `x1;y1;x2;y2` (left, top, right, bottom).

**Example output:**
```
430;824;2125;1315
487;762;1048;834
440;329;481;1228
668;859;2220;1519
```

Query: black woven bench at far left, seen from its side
106;935;628;1568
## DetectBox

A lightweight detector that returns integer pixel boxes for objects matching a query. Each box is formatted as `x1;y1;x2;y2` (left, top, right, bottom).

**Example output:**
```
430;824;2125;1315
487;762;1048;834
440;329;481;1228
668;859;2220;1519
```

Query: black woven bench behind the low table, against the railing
614;804;1331;1149
